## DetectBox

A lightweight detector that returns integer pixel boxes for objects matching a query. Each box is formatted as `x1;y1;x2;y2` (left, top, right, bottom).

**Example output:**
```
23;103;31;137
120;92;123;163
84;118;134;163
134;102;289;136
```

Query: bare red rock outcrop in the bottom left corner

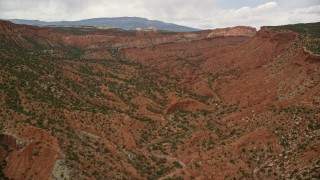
0;127;58;179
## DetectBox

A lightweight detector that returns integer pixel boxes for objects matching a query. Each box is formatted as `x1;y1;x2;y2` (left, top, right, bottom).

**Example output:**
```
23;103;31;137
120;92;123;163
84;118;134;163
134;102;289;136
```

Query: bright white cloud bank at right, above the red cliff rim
181;2;320;29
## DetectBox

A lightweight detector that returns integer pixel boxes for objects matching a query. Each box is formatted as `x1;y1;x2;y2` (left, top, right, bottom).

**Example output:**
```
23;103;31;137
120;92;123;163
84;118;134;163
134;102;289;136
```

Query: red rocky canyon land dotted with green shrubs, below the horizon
0;21;320;179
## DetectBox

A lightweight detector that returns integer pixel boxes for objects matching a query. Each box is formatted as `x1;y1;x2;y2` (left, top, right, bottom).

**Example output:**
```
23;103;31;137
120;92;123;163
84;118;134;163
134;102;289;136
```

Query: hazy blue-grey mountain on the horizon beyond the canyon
9;17;199;32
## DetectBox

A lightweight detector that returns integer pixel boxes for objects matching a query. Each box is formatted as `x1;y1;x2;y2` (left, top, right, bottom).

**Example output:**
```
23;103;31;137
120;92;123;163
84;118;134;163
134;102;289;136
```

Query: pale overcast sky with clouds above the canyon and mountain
0;0;320;29
